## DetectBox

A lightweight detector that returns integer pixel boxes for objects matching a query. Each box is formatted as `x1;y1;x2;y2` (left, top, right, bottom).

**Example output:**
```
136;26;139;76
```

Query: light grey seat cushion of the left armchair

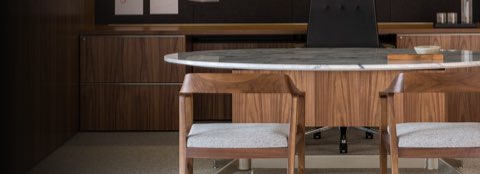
187;123;290;148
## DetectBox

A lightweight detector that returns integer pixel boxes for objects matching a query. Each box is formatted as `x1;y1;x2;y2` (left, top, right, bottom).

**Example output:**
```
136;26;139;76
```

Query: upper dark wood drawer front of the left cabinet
80;36;186;83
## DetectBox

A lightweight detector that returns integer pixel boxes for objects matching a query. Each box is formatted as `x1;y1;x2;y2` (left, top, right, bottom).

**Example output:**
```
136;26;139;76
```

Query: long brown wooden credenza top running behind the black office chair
84;23;480;35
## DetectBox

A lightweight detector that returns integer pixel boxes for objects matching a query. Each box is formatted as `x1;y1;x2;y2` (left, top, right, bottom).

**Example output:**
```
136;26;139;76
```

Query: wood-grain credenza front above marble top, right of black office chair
397;33;480;51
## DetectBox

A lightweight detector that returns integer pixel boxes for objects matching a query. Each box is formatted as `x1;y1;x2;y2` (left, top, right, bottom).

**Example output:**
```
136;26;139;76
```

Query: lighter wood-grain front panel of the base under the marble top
232;70;445;127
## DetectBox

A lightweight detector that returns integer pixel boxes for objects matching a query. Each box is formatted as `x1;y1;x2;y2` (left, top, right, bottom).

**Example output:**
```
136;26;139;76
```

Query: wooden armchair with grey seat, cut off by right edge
380;72;480;174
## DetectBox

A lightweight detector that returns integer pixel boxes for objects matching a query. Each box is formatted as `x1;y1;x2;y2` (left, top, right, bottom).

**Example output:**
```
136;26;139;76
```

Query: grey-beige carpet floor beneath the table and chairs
29;129;480;174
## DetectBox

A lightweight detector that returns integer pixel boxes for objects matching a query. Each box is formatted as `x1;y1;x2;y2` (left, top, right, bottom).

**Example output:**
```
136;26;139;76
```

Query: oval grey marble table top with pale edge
164;48;480;71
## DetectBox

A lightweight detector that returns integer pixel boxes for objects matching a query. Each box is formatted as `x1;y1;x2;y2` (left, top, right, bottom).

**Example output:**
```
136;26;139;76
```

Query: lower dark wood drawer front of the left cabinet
80;84;180;131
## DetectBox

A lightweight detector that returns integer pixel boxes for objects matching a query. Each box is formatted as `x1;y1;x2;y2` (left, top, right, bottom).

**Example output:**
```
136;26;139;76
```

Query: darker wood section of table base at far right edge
445;67;480;122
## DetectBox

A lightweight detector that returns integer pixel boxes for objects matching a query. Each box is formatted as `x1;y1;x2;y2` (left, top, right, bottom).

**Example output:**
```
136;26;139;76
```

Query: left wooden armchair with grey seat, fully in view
179;74;305;174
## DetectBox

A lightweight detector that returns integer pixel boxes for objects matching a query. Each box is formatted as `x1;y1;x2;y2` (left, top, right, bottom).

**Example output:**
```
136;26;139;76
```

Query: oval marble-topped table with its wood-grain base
164;48;480;169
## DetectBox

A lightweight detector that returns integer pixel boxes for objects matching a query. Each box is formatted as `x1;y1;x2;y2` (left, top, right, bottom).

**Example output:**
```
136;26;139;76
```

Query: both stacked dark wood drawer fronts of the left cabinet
80;35;189;131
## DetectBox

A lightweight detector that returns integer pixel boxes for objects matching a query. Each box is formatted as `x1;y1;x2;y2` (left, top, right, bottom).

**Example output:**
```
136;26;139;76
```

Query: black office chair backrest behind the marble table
307;0;379;47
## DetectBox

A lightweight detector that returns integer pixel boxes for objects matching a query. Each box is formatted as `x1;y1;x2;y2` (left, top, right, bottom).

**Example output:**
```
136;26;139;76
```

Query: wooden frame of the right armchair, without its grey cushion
380;72;480;174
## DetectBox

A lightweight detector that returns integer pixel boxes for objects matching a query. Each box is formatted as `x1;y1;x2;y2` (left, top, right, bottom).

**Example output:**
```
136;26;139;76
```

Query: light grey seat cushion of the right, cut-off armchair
397;122;480;148
